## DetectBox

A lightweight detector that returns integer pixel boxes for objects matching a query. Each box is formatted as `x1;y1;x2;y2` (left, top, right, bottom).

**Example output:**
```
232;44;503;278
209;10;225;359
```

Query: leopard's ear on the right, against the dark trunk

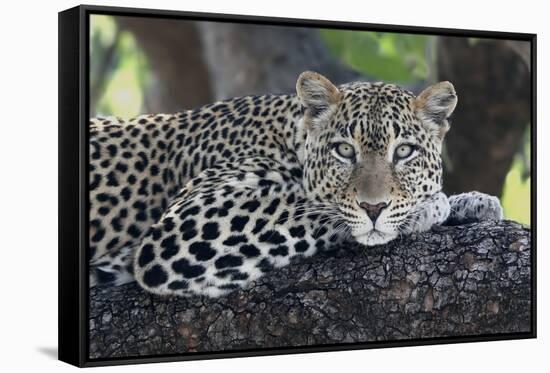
414;82;458;140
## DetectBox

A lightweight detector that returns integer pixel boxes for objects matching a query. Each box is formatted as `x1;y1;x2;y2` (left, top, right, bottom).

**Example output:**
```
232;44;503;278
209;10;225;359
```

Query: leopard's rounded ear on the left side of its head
296;71;341;123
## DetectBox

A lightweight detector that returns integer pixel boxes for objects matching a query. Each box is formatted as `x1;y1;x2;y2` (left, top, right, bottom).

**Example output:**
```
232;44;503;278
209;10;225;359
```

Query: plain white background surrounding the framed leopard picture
0;0;550;373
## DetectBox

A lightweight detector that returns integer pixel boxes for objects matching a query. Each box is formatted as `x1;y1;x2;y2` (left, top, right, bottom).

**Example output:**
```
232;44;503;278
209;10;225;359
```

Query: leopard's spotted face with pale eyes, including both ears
298;73;456;246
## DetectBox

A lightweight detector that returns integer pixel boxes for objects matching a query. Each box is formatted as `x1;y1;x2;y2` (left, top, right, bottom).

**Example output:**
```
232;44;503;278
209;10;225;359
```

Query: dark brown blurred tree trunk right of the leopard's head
438;37;531;196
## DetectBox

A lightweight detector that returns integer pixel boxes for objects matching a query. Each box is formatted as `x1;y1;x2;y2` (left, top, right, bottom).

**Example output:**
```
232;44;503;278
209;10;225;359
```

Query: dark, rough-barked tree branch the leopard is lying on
90;221;531;358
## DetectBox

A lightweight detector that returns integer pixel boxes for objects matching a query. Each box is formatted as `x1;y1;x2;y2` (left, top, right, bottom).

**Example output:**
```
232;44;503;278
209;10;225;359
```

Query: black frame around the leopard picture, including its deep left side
58;5;537;367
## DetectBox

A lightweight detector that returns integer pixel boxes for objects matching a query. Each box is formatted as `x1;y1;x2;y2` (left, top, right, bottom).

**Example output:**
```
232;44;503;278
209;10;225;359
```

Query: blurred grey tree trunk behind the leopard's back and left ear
197;22;365;99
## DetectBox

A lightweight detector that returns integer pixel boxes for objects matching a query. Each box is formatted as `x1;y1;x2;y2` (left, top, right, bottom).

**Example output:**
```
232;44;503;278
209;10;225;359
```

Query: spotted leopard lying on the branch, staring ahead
88;71;503;297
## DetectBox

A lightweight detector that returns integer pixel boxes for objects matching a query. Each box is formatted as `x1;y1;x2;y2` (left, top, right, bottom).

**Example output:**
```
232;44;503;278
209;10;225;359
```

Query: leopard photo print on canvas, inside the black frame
87;14;533;360
